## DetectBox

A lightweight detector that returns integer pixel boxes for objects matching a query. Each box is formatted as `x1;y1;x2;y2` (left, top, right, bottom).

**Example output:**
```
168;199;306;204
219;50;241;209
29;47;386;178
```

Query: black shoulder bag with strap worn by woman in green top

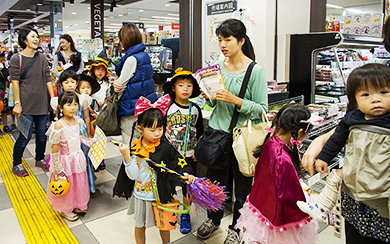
194;62;256;169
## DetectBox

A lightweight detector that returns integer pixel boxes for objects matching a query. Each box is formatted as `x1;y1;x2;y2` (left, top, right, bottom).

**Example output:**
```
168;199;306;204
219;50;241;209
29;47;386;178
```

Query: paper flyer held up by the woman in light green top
194;64;225;99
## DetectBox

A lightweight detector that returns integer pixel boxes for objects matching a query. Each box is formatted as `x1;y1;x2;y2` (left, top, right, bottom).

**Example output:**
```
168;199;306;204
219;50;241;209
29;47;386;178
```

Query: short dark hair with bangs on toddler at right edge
347;63;390;109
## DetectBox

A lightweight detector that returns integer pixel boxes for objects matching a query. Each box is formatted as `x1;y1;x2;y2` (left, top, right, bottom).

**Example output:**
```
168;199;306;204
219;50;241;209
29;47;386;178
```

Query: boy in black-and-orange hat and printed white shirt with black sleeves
163;68;204;234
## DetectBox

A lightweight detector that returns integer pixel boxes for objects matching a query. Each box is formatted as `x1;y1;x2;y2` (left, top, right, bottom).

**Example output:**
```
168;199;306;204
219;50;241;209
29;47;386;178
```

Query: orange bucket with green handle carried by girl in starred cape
152;199;190;230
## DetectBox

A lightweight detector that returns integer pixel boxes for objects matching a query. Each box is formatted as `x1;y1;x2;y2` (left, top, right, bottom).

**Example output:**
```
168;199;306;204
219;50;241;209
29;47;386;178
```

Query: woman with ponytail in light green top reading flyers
197;19;268;244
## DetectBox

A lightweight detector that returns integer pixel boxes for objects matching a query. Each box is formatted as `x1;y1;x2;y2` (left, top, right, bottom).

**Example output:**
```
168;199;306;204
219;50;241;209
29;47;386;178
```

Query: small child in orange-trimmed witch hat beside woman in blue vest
86;50;111;171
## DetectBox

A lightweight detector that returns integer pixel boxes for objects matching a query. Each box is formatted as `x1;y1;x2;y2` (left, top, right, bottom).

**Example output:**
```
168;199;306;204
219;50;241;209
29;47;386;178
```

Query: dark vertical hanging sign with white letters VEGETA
91;0;104;39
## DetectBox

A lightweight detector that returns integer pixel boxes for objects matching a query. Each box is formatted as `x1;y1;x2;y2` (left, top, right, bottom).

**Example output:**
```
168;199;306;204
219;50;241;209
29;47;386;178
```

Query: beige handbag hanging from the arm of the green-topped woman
233;106;271;177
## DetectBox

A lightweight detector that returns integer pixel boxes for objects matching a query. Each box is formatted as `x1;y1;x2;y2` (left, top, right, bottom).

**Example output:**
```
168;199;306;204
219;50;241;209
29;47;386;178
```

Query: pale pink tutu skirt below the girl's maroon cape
236;203;318;244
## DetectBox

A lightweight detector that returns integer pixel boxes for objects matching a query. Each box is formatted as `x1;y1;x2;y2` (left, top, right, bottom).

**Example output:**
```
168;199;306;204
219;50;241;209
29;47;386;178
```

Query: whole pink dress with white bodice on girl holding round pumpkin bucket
47;118;93;212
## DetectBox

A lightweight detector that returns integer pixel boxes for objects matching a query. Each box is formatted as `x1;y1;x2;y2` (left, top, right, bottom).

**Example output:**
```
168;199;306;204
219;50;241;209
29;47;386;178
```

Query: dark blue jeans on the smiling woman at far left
13;115;47;166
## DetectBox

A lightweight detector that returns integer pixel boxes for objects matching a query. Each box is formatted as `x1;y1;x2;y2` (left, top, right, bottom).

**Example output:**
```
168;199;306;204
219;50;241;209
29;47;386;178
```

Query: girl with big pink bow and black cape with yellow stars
114;95;195;244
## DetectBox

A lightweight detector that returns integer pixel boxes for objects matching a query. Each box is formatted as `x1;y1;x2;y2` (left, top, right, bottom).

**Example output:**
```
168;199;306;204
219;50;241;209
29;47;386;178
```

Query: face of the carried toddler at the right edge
355;86;390;119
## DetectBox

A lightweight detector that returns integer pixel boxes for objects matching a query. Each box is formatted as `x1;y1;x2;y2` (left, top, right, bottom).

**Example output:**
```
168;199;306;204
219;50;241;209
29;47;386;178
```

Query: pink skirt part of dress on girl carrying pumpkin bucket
47;150;89;213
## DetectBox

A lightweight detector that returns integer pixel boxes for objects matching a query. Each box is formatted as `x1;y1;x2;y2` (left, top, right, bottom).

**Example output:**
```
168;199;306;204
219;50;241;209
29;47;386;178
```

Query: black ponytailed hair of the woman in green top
215;19;255;61
